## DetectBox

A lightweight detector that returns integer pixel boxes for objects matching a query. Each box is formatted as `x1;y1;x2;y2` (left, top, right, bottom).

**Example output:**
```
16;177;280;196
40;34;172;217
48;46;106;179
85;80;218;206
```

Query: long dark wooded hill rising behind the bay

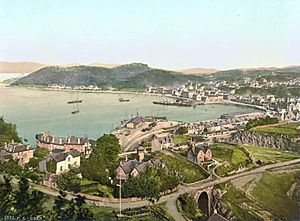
13;63;203;88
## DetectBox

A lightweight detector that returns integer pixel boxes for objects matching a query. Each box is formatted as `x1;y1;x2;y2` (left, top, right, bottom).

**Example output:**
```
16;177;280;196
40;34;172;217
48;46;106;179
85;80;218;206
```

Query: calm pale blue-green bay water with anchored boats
0;84;253;144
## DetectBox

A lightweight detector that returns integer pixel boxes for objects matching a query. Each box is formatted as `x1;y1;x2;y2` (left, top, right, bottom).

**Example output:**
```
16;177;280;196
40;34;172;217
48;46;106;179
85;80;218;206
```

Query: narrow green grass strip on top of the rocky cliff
251;123;300;137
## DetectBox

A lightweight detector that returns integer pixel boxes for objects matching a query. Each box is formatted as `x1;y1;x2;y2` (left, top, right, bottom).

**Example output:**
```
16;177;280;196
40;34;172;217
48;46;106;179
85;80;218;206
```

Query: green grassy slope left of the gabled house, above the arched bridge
156;153;207;183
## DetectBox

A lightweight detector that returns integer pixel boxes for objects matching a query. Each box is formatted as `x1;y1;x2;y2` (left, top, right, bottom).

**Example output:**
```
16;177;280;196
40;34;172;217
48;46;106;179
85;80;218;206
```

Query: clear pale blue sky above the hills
0;0;300;69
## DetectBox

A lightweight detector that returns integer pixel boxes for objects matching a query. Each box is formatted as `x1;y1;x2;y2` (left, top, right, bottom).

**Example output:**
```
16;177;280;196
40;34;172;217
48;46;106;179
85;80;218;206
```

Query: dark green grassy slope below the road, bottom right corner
251;172;300;220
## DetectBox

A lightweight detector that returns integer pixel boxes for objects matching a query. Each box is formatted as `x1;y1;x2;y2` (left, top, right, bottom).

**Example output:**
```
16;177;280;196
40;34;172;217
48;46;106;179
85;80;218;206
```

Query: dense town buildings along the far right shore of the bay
146;78;300;121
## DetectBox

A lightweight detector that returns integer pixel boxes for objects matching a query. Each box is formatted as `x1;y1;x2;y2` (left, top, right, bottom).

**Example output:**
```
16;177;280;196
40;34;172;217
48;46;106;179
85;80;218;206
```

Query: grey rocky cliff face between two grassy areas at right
229;131;300;152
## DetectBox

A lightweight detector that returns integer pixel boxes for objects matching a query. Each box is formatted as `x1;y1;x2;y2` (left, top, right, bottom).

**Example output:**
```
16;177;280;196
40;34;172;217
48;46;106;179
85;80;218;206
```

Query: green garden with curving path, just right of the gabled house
211;143;252;176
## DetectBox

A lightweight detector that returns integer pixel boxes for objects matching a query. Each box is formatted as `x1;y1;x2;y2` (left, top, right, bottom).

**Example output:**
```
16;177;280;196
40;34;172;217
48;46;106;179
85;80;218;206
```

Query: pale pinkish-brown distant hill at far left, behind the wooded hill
0;62;47;73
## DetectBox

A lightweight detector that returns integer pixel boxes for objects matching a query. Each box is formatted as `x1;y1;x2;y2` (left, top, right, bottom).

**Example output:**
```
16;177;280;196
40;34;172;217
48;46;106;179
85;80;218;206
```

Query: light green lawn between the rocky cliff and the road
244;145;300;163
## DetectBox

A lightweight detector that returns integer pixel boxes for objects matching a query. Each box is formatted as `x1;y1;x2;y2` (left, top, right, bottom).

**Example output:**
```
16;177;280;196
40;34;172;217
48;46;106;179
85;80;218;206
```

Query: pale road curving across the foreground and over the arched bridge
32;159;300;221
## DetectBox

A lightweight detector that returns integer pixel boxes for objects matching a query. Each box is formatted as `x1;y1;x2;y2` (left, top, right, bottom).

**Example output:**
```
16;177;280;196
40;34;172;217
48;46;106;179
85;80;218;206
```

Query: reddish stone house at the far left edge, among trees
0;141;34;165
